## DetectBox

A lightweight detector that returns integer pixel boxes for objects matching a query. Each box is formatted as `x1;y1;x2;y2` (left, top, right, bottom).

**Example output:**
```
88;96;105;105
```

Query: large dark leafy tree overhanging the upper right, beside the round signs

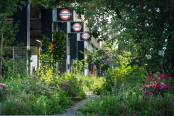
22;0;174;75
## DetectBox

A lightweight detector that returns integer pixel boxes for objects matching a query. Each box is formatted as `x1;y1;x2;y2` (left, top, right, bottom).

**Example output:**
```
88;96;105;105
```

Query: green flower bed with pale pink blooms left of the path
0;76;72;115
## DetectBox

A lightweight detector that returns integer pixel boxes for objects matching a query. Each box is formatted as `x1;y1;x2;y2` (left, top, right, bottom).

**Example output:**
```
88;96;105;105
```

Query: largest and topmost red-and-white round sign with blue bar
59;9;71;20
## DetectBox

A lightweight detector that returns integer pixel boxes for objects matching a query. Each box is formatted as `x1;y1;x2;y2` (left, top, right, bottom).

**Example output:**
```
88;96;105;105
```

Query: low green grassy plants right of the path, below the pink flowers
79;89;174;116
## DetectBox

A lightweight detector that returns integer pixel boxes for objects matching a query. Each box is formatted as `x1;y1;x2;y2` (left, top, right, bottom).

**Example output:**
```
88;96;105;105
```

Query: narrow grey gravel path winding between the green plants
57;92;96;116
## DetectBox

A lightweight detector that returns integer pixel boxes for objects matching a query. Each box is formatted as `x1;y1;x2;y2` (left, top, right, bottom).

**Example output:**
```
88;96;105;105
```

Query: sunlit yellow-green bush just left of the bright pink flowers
103;56;147;92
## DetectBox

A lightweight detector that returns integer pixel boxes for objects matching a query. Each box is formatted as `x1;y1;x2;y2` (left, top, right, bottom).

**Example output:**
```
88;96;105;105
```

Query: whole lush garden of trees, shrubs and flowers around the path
0;0;174;116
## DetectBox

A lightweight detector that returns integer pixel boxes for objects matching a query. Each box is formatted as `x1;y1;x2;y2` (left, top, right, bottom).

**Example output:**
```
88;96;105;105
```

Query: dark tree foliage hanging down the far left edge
0;0;26;78
